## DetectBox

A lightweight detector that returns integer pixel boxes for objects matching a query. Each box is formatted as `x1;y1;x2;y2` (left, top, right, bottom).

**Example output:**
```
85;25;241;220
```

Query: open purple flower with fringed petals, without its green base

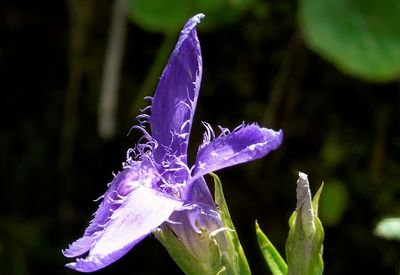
63;14;283;272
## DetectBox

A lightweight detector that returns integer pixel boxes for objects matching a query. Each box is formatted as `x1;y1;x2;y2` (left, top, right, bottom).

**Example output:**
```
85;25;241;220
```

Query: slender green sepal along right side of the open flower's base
211;173;251;274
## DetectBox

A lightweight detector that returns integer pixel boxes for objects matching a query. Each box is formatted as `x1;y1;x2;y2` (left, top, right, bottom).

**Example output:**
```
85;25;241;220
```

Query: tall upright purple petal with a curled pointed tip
150;14;204;163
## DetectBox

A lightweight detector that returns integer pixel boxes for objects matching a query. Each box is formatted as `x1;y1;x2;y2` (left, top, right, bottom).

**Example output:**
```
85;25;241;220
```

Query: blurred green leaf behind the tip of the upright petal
129;0;252;33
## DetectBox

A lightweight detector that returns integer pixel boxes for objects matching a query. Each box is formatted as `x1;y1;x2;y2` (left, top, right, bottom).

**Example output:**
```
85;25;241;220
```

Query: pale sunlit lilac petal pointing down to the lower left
67;185;183;272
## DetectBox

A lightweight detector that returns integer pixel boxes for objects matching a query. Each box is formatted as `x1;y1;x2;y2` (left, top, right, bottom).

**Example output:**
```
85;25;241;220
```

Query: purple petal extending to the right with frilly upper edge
193;124;283;179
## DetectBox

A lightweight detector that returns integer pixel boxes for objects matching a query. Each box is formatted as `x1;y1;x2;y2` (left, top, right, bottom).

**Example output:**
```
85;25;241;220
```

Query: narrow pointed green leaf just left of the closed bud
256;221;288;275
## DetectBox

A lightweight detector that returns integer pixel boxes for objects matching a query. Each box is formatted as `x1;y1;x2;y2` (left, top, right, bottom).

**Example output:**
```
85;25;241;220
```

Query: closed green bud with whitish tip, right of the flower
286;173;324;275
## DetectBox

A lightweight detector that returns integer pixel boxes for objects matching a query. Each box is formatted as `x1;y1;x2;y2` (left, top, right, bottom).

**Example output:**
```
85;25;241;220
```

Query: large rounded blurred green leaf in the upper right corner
298;0;400;81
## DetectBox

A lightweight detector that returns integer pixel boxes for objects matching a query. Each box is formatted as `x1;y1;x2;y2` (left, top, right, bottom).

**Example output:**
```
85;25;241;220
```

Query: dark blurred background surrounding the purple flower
0;0;400;275
